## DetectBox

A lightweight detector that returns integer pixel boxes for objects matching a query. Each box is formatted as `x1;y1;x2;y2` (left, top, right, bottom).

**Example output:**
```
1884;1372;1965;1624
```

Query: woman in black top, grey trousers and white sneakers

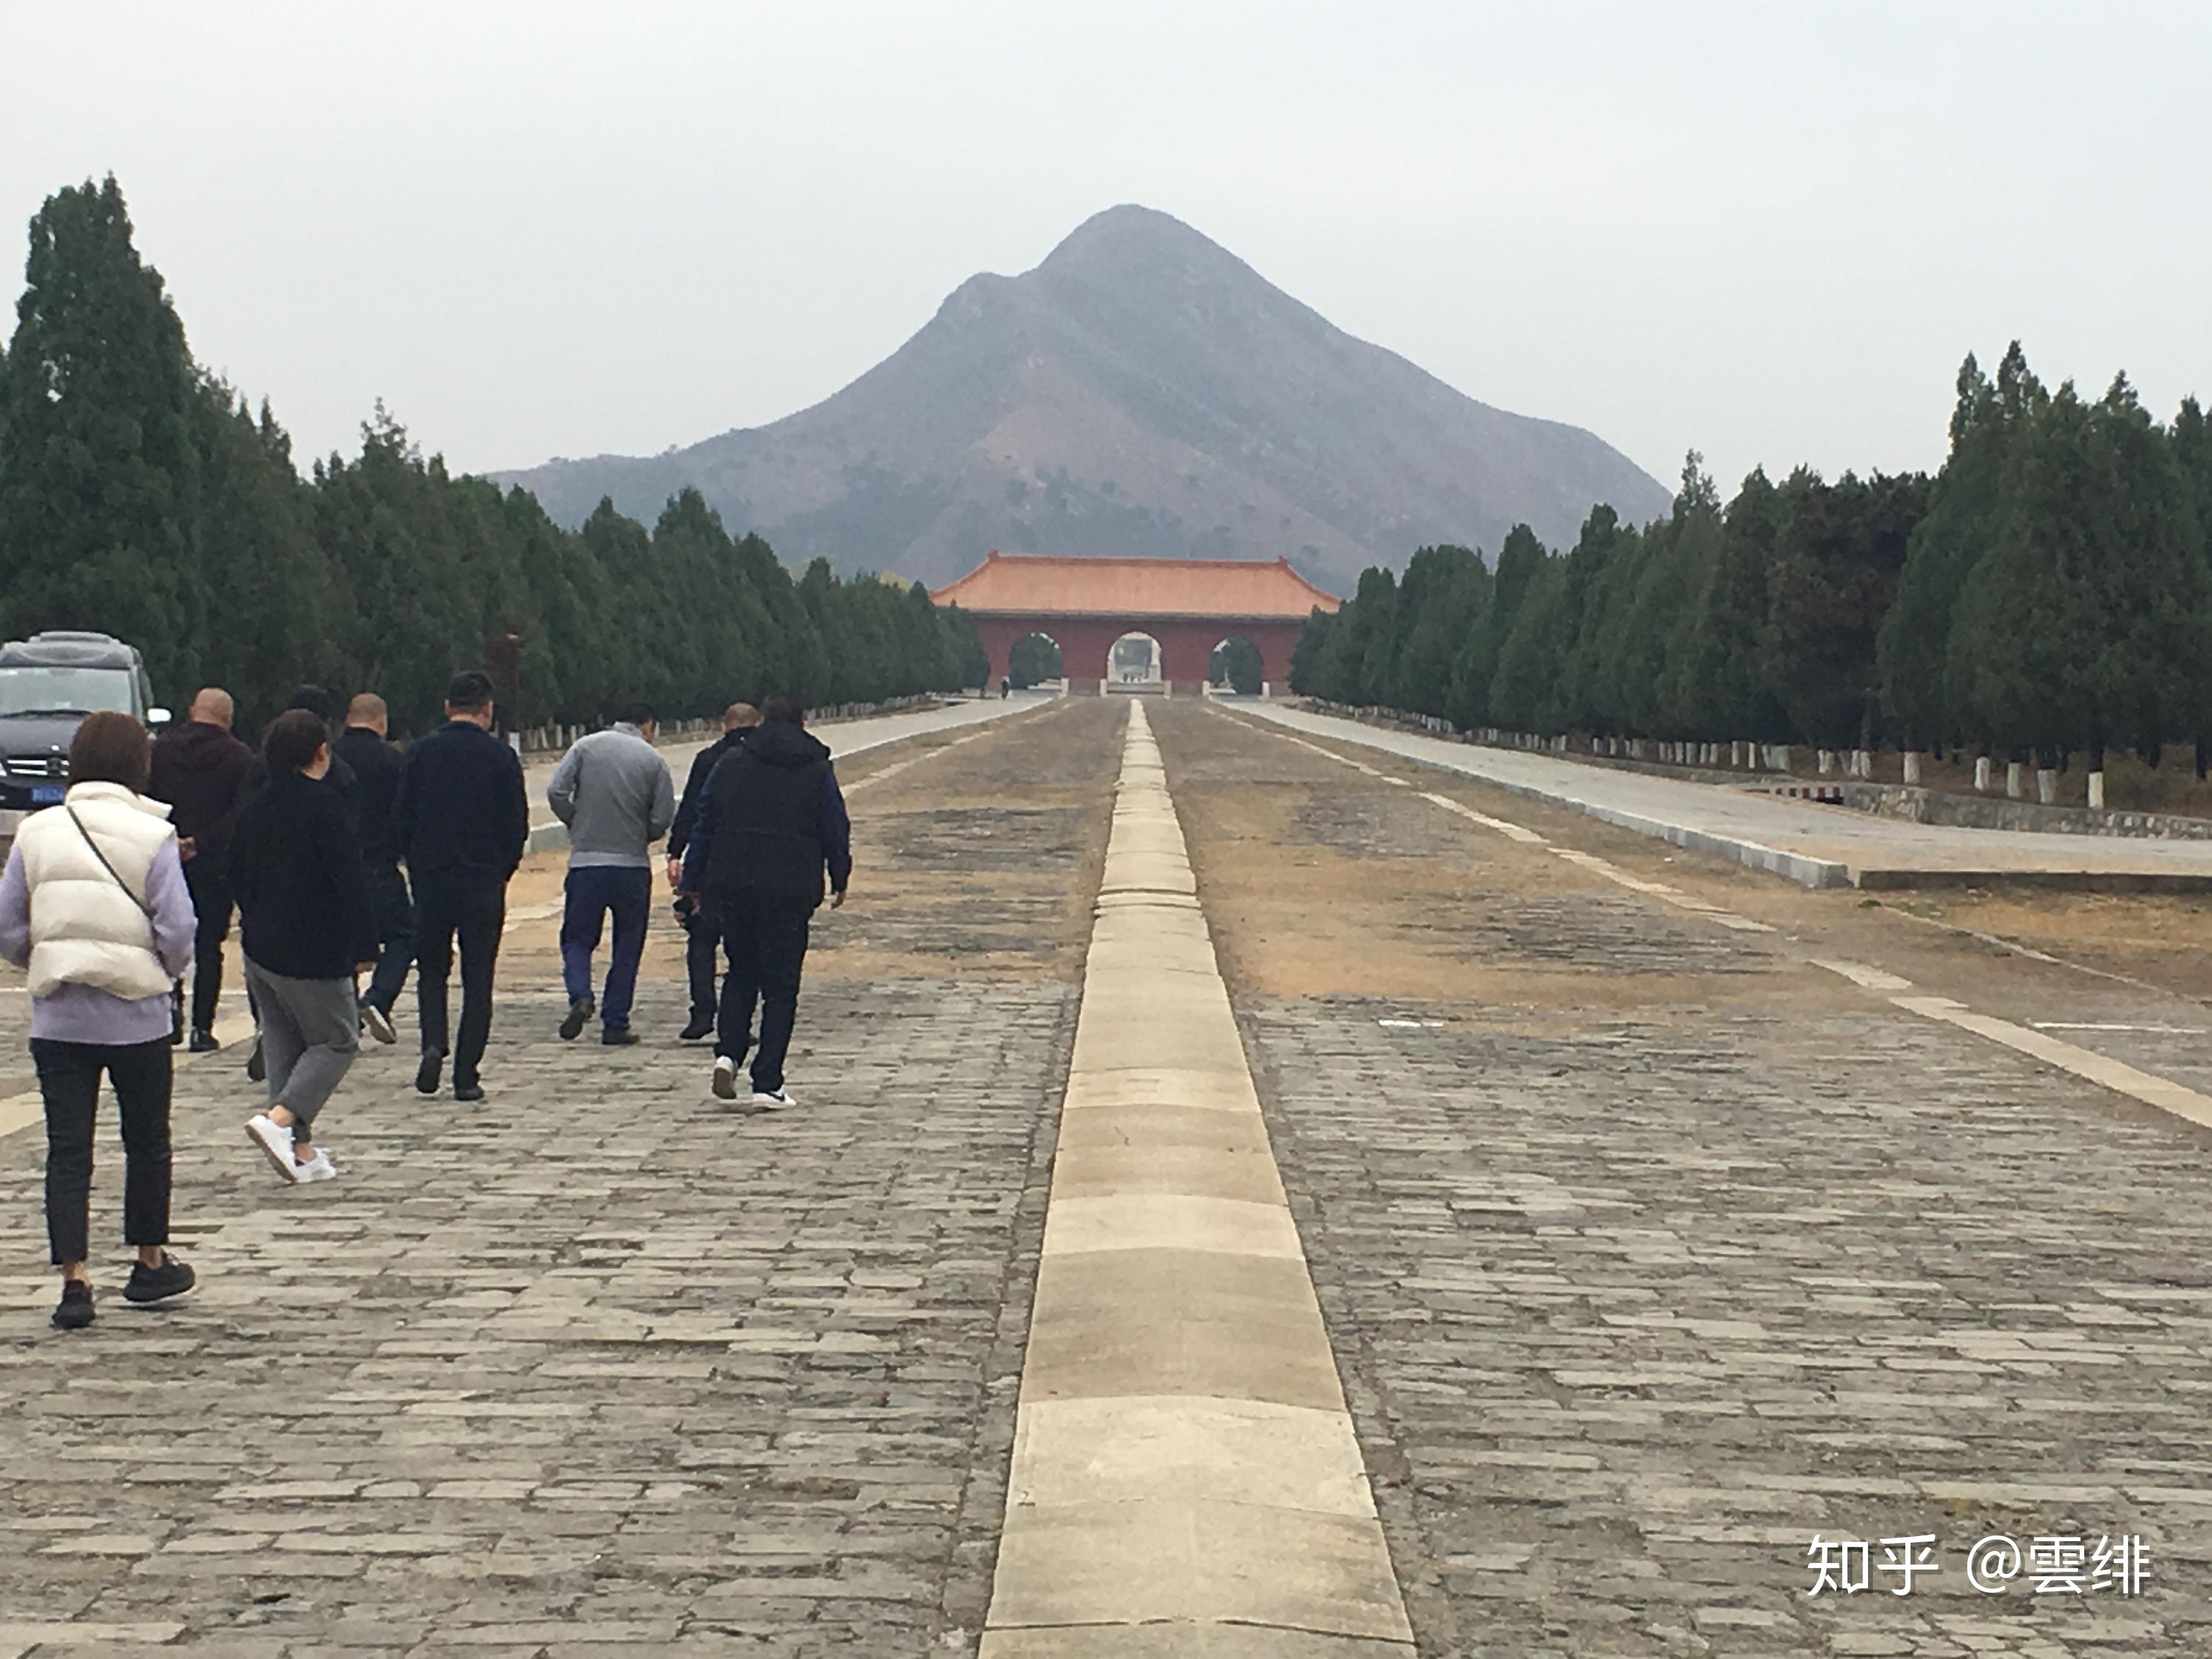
230;708;376;1181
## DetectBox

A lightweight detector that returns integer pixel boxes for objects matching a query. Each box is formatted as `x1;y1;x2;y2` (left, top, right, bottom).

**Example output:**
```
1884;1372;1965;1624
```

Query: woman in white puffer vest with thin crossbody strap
0;712;195;1329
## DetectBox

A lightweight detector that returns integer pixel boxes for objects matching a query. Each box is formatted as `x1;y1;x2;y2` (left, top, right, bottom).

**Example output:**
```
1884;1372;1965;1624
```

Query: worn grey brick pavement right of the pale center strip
1157;708;2212;1659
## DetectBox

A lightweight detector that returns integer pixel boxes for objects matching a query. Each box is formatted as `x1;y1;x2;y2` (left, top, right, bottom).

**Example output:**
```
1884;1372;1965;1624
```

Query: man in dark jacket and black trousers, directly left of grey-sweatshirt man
392;668;531;1102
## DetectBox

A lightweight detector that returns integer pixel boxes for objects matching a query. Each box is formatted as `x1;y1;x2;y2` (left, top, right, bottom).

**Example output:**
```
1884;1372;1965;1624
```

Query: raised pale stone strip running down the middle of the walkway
982;701;1413;1659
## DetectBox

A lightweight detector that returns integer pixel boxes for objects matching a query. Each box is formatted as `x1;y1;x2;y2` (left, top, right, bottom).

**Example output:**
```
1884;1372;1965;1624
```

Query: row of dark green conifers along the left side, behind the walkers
0;177;986;730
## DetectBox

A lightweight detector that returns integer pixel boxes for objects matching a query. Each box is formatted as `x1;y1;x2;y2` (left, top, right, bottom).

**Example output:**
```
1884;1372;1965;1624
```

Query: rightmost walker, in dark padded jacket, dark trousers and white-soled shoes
681;697;851;1110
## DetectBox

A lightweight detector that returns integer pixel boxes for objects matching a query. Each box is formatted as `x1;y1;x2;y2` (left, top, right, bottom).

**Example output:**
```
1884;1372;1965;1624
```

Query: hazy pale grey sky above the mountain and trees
0;0;2212;500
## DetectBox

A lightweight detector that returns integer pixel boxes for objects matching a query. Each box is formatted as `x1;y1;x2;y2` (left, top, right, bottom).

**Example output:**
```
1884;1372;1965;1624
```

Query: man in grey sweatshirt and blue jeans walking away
546;703;677;1046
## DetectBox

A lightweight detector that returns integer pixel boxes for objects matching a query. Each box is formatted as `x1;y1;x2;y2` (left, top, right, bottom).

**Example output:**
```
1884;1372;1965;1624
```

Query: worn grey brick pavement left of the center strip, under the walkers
0;710;1115;1659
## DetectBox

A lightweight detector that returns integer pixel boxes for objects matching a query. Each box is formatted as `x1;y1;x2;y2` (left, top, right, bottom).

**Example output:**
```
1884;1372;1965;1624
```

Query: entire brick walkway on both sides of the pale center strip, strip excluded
13;699;2212;1659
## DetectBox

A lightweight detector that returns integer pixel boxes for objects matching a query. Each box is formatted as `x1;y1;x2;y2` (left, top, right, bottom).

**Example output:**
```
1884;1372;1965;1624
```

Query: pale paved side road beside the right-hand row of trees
1239;699;2212;887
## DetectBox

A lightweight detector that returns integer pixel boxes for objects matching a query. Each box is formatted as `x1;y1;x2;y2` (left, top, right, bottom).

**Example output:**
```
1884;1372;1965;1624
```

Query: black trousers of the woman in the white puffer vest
31;1037;170;1267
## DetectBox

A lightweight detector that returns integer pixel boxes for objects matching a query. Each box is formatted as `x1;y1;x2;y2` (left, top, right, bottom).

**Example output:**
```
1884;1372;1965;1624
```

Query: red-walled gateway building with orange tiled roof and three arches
929;553;1338;697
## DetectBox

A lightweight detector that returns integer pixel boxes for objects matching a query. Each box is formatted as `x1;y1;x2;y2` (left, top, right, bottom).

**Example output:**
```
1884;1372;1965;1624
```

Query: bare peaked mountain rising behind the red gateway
495;206;1670;593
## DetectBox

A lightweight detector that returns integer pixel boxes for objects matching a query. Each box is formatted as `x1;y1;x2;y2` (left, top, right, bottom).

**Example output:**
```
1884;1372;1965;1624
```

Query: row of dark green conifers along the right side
1292;343;2212;770
